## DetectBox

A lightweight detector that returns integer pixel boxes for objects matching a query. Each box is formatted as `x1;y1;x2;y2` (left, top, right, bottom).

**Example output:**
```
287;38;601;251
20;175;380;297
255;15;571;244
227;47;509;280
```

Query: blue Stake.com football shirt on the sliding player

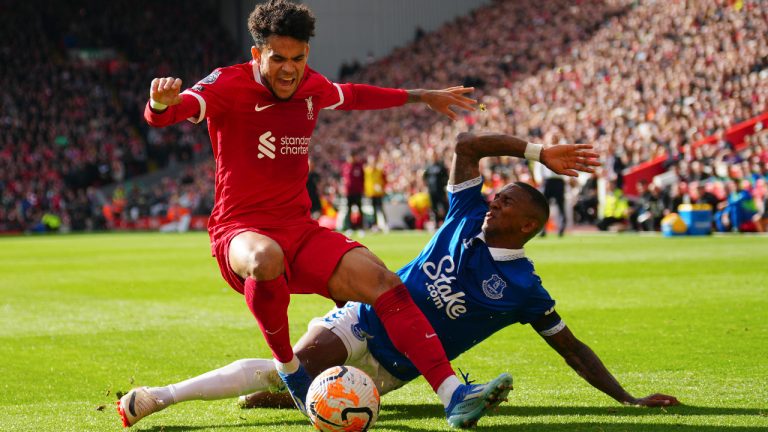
356;177;557;381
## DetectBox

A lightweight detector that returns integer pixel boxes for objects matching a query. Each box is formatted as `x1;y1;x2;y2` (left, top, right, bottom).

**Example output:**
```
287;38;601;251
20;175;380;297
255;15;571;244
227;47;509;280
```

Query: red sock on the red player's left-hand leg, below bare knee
245;275;293;363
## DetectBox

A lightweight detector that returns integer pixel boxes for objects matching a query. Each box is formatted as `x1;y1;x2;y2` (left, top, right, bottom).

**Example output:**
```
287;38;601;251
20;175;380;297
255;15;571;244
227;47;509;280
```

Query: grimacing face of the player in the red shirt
251;35;309;100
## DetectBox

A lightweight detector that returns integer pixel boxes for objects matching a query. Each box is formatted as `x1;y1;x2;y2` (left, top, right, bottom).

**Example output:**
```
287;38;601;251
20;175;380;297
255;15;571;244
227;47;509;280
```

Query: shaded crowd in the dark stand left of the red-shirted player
0;0;235;232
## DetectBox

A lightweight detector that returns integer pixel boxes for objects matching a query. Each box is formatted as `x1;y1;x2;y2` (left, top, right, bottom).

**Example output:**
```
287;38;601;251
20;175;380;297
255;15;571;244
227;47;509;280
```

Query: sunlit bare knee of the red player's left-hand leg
229;233;285;280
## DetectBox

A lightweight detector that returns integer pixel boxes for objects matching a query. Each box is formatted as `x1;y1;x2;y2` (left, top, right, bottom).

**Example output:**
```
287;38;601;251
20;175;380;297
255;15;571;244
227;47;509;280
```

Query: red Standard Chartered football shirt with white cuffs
144;61;408;240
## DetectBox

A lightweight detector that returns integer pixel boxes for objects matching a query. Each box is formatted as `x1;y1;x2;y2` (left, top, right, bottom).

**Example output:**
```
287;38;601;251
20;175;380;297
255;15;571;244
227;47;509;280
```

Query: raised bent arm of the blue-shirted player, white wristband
448;133;600;184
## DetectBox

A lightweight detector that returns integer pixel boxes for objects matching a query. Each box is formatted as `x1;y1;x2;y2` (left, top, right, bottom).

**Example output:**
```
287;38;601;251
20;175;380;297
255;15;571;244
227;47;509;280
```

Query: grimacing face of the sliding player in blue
483;184;537;247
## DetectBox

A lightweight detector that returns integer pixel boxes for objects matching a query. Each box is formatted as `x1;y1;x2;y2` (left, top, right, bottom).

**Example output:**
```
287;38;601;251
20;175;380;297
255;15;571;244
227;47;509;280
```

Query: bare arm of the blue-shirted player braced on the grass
542;327;680;407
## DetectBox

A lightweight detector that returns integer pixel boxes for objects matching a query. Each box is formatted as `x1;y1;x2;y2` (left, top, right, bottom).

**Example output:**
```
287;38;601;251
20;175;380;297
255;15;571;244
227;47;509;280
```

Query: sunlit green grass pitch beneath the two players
0;233;768;432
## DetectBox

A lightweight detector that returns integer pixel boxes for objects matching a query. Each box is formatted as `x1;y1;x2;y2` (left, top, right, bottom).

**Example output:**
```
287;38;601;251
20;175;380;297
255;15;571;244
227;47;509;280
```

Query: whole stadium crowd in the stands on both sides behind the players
0;0;768;231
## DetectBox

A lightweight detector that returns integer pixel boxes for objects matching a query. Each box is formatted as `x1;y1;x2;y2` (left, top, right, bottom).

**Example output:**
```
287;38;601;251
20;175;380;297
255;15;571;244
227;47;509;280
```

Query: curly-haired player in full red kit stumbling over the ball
118;0;511;426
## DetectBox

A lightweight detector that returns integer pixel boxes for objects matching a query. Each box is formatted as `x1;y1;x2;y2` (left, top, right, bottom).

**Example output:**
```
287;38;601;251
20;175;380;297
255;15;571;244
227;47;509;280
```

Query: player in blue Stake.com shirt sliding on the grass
118;134;679;427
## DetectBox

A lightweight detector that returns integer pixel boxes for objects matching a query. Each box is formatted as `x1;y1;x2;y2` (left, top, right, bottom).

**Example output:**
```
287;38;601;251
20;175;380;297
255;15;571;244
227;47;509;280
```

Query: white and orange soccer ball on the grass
307;366;379;432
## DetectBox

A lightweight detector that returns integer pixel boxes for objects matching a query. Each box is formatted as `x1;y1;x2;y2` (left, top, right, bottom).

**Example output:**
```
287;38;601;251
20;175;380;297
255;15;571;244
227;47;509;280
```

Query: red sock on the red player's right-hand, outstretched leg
373;284;455;391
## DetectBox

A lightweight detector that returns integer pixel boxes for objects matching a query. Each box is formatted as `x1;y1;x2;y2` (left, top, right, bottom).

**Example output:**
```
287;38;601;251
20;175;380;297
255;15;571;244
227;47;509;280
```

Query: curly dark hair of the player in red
248;0;315;46
